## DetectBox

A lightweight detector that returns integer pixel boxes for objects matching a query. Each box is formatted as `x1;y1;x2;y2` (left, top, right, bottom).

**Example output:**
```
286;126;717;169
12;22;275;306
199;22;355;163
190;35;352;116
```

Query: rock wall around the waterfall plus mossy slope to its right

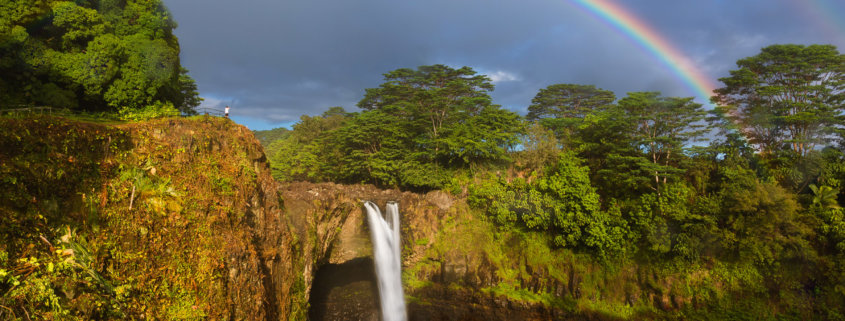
282;183;710;320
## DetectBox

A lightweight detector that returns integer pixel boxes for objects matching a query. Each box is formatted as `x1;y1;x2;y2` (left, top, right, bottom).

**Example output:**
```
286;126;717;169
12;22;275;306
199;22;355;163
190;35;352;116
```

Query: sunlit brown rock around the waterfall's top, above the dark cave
282;182;454;296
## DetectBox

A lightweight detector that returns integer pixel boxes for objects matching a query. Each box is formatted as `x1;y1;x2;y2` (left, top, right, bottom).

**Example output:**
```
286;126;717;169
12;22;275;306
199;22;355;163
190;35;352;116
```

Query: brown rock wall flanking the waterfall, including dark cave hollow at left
282;183;453;320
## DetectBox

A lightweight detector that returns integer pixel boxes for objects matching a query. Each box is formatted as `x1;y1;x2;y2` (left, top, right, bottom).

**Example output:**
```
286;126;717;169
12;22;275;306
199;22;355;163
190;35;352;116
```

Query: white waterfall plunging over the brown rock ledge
364;201;407;321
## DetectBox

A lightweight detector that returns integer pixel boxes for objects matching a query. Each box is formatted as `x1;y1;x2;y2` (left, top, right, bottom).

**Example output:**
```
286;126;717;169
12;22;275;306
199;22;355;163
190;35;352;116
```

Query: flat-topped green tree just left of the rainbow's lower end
576;92;705;198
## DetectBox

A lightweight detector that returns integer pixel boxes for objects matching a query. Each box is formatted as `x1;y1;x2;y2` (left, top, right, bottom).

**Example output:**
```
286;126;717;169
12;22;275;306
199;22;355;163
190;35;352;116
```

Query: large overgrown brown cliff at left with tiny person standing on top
0;117;304;320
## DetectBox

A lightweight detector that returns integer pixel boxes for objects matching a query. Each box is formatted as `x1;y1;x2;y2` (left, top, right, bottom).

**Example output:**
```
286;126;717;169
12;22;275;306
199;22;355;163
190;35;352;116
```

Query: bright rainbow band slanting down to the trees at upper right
572;0;717;104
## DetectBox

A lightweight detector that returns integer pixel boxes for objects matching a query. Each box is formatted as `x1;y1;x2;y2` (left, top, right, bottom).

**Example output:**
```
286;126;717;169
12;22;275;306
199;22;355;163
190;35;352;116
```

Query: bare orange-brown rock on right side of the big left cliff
120;117;301;320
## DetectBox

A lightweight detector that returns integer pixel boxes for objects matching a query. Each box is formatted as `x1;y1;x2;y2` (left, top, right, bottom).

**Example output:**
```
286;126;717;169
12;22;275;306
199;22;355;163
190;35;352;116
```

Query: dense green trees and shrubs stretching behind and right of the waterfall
260;45;845;320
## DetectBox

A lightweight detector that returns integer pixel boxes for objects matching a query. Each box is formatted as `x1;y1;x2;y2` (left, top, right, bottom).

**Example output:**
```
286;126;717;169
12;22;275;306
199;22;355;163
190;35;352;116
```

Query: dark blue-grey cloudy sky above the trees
164;0;845;130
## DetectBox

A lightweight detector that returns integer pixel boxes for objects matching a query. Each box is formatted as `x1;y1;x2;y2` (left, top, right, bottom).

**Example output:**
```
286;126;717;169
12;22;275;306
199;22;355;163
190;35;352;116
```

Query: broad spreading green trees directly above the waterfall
268;65;522;190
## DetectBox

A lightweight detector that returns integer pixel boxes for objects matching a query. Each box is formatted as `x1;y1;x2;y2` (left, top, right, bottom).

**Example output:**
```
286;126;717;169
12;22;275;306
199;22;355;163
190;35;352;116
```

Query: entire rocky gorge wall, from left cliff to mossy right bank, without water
0;116;840;320
